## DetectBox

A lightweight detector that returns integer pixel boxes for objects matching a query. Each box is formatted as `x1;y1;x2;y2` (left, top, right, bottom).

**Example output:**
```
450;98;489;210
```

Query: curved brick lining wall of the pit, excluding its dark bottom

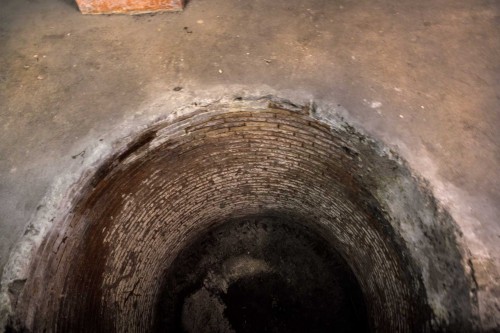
7;98;474;332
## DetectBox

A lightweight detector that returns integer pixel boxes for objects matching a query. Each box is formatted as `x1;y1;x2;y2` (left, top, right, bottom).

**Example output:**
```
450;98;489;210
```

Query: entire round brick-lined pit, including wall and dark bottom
7;101;472;332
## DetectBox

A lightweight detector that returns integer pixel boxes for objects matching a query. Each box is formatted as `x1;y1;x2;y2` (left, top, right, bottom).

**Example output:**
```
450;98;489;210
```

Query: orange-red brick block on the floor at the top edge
76;0;184;14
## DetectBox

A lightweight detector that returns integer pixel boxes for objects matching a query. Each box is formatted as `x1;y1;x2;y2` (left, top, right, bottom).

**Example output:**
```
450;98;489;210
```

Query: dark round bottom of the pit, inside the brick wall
157;217;369;333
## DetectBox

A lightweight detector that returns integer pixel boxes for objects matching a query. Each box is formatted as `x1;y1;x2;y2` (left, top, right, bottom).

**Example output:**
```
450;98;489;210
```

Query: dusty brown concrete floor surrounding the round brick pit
0;0;500;329
